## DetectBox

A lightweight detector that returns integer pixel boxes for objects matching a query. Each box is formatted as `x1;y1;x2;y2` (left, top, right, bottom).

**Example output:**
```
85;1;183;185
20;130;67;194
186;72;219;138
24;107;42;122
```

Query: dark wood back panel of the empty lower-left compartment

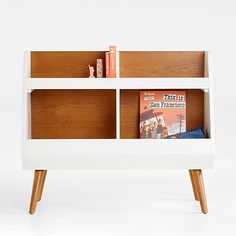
31;90;116;139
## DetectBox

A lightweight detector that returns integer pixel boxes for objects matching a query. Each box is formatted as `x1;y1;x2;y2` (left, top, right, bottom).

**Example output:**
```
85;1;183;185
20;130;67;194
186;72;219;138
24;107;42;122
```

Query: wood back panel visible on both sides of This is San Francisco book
120;89;204;139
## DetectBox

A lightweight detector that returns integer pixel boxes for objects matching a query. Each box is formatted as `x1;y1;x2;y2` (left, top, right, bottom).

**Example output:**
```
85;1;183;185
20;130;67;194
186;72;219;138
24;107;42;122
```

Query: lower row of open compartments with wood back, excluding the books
29;89;211;139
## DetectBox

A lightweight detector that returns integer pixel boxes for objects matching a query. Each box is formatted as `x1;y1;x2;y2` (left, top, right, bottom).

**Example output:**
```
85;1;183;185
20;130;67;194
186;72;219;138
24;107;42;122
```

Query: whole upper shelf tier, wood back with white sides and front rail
24;51;212;91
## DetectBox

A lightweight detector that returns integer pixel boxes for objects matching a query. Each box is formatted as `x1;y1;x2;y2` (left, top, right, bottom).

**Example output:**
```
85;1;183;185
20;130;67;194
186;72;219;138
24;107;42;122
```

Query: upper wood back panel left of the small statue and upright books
31;51;105;78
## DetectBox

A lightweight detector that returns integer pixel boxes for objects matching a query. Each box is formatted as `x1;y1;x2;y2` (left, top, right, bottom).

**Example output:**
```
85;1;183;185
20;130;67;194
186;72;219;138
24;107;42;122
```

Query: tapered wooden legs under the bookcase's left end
29;170;46;214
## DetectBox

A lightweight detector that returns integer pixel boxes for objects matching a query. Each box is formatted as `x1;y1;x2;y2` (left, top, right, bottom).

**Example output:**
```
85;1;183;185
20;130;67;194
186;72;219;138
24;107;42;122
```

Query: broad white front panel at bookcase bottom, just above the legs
23;139;214;169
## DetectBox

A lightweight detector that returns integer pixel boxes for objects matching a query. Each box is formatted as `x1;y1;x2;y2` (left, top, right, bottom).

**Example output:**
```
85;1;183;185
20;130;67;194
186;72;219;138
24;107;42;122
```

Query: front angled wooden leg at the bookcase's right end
192;170;208;214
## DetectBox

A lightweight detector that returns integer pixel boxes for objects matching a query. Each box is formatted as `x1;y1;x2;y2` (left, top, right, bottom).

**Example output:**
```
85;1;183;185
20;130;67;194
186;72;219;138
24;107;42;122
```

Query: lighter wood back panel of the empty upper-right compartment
120;51;204;78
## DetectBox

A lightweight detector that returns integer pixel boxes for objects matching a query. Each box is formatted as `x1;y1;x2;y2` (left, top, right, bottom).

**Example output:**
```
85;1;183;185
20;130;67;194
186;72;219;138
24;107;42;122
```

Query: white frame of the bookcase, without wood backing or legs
22;51;215;170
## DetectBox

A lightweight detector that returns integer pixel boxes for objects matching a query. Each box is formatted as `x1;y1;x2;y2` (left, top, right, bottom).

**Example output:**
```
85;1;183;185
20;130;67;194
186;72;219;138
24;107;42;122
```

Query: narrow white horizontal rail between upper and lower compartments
25;78;212;91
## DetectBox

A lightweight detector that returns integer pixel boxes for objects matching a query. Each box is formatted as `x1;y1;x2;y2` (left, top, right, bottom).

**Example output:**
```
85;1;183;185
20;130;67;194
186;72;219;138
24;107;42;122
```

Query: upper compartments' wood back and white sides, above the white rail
25;51;211;78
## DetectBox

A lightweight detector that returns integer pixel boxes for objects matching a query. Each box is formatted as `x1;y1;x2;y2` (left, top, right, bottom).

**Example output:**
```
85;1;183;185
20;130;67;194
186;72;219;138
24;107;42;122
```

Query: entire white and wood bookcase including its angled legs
23;51;214;214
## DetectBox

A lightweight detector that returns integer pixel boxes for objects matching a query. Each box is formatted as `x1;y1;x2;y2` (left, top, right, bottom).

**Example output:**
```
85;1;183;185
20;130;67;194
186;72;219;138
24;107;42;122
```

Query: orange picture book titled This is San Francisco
140;90;186;139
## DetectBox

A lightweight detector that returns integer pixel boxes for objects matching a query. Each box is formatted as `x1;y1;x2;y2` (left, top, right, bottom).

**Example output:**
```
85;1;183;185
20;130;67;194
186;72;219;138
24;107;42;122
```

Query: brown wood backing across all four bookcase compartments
31;51;204;139
